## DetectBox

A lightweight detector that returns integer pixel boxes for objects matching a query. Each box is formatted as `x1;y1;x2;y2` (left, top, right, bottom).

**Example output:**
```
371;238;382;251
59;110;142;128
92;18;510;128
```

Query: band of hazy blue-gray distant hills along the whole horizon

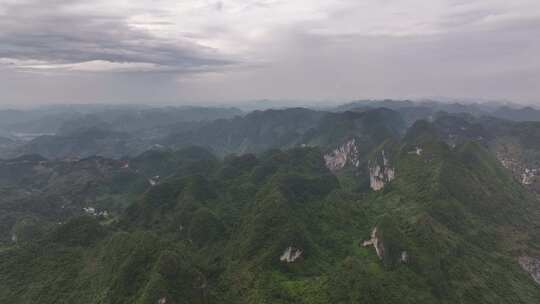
0;100;540;158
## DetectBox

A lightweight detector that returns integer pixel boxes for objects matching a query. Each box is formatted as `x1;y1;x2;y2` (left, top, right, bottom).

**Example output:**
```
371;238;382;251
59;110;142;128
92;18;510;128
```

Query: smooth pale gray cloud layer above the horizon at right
171;14;540;104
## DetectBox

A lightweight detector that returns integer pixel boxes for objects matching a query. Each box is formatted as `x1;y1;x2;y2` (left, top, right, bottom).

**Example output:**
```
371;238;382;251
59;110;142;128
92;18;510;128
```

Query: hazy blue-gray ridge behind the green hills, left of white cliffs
163;108;403;155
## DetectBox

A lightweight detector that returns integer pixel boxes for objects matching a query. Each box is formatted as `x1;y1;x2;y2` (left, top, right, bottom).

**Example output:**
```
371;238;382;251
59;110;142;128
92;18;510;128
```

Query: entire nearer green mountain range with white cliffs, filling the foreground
0;101;540;304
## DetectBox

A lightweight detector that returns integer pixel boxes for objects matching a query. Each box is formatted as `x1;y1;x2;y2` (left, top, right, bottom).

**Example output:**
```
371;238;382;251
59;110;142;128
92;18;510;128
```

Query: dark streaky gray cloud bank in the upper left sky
0;0;231;72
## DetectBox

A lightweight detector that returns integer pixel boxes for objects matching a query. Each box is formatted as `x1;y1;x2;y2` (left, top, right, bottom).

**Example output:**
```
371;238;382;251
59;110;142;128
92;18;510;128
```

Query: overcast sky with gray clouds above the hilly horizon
0;0;540;105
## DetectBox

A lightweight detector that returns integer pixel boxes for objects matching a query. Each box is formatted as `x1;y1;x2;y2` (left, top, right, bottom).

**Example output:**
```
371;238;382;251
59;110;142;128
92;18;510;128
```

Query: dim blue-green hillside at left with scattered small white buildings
0;147;215;241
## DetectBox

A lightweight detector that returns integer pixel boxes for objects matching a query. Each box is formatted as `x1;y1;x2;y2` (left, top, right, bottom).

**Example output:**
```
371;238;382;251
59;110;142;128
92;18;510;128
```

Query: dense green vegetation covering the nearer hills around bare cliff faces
0;110;540;304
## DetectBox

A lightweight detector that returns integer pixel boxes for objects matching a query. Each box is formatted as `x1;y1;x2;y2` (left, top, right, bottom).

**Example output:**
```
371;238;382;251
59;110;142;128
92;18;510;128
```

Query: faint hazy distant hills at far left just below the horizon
0;106;242;159
